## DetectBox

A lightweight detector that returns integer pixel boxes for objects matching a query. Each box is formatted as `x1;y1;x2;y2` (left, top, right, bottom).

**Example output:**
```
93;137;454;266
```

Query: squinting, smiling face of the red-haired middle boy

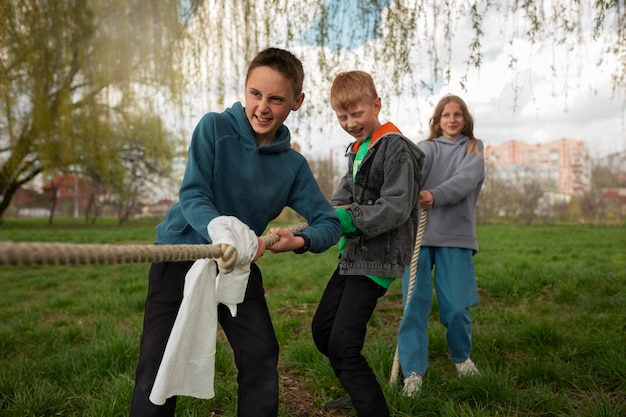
335;97;381;142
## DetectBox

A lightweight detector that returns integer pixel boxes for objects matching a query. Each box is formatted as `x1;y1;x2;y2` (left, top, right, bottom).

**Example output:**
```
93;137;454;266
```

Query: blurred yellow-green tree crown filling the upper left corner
0;0;193;216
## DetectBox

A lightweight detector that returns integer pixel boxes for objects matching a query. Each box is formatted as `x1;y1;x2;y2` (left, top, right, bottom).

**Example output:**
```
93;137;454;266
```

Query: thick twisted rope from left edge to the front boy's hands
0;222;308;266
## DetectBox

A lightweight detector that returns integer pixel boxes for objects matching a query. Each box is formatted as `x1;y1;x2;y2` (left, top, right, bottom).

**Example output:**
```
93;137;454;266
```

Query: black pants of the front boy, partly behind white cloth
130;262;278;417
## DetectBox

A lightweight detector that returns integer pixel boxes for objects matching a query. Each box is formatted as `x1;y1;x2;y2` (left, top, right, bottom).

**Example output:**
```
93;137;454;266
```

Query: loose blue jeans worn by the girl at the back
398;246;478;377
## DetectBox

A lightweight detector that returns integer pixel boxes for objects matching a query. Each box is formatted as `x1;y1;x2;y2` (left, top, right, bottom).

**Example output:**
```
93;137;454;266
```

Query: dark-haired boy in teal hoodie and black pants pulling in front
130;48;341;417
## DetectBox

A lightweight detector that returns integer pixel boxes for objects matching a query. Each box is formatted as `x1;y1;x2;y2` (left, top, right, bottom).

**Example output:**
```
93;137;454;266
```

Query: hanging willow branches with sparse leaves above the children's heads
177;0;626;132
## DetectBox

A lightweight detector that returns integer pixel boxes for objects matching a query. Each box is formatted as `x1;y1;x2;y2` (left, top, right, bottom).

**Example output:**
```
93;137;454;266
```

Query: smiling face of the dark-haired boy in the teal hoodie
245;66;304;146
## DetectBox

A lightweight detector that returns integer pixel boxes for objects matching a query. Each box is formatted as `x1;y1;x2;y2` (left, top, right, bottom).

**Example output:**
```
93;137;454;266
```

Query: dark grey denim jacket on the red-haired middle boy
331;133;424;278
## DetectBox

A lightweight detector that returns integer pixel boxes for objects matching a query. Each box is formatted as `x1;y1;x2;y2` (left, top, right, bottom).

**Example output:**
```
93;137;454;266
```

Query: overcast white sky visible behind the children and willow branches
288;0;626;157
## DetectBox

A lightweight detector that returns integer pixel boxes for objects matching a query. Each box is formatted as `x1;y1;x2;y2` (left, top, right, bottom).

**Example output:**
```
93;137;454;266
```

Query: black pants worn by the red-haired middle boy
312;269;389;417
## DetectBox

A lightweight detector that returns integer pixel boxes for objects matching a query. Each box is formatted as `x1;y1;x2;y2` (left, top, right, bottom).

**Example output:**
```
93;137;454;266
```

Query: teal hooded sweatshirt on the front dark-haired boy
156;102;341;253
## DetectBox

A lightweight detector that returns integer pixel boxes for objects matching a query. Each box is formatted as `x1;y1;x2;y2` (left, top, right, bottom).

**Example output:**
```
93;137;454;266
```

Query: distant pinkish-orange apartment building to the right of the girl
485;139;591;196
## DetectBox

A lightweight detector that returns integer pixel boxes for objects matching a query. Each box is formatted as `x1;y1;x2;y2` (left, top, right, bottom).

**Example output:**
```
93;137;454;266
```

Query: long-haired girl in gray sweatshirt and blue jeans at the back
398;95;485;397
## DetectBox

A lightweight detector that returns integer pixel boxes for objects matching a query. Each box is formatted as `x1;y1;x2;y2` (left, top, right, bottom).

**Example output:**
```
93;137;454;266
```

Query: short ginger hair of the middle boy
330;71;378;110
